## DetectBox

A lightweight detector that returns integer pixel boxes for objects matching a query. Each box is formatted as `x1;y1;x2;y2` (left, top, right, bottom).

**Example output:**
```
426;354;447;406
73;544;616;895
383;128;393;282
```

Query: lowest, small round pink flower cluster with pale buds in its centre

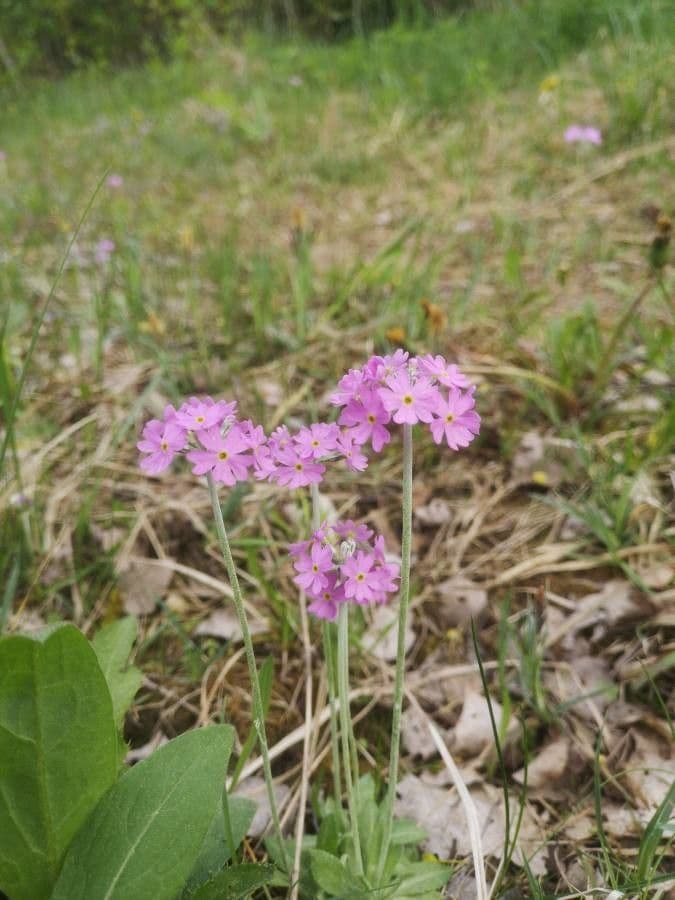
289;519;399;622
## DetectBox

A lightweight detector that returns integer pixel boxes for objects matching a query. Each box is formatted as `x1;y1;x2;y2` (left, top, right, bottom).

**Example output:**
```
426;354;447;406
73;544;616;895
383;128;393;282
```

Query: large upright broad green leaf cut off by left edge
0;625;117;900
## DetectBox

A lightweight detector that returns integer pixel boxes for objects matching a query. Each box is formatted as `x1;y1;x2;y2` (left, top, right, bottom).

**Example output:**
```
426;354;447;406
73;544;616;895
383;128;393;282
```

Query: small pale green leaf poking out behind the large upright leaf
91;616;143;728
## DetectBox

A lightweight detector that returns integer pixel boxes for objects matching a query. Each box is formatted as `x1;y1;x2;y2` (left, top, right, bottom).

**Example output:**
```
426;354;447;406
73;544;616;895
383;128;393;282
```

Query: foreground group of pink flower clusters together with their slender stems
137;350;480;885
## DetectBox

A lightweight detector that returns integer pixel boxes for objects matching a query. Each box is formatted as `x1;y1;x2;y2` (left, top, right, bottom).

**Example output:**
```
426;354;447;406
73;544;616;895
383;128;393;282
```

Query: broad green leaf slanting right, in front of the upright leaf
52;725;234;900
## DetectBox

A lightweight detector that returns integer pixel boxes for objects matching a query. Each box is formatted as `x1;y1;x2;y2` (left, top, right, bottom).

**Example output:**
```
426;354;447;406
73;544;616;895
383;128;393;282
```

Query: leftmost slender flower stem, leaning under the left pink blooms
206;472;290;872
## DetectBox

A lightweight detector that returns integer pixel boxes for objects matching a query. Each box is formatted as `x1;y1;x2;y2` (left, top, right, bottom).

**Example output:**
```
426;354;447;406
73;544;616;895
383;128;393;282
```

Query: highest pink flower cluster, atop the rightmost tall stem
331;350;480;453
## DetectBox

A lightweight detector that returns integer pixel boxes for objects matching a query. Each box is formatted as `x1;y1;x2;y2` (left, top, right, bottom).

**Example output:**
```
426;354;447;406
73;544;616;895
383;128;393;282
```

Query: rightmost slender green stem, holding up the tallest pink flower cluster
377;425;413;883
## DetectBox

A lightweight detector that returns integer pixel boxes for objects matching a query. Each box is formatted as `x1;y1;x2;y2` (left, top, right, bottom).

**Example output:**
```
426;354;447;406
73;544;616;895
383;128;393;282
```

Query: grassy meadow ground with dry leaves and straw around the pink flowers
0;0;675;897
